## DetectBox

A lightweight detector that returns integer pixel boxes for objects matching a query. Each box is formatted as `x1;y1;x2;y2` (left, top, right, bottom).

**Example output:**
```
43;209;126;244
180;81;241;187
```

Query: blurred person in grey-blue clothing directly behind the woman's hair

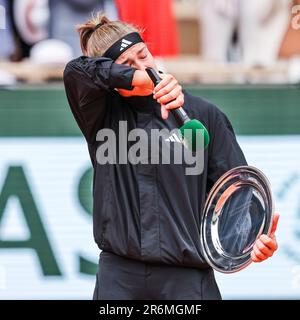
49;0;117;56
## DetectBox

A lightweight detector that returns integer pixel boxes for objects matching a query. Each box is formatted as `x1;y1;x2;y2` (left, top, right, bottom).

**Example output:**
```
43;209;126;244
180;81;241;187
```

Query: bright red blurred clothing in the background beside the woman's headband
116;0;178;57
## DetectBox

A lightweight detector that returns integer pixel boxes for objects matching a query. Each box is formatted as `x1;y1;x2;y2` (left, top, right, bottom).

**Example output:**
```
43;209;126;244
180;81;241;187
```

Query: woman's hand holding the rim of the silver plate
251;213;279;262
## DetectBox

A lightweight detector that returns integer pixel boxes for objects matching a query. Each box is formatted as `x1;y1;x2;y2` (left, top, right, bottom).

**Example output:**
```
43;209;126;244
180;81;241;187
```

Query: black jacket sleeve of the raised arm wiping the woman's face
63;56;135;143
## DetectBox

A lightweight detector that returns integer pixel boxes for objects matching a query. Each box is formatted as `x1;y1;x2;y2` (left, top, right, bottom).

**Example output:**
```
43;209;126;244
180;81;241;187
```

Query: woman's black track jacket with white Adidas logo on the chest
64;56;247;268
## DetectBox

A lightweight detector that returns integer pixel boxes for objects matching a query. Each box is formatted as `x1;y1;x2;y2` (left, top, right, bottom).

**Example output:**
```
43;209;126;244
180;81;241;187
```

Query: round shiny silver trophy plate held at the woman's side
200;166;274;273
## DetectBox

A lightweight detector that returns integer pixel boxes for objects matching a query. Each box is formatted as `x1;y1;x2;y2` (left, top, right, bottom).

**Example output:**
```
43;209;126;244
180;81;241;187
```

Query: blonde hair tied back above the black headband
76;12;142;57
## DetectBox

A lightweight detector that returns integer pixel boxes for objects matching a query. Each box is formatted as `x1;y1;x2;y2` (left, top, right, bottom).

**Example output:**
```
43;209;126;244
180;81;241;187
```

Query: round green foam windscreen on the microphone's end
179;119;209;151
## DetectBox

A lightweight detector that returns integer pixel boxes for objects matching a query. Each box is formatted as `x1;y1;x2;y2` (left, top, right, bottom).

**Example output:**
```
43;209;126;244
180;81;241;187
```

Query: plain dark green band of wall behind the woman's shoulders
0;85;300;137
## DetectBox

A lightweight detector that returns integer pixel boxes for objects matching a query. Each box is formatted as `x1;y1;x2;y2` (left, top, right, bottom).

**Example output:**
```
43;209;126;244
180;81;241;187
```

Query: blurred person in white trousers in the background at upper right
199;0;291;65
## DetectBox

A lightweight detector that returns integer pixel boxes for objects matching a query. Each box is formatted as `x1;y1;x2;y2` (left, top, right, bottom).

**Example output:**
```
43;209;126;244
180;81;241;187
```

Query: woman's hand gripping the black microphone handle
153;73;184;119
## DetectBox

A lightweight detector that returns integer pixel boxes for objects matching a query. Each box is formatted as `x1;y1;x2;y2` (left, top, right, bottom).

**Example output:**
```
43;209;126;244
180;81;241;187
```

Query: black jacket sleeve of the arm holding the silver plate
207;107;247;192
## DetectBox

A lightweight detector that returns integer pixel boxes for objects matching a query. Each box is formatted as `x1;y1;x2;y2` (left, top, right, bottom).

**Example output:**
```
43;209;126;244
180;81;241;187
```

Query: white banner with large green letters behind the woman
0;136;300;299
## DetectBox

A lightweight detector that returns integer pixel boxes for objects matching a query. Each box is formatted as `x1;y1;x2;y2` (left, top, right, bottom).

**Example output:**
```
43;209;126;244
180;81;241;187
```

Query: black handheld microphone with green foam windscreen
145;68;209;151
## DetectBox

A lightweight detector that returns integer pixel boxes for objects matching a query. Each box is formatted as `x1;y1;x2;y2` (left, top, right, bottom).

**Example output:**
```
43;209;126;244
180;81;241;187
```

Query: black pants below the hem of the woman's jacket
93;251;221;300
